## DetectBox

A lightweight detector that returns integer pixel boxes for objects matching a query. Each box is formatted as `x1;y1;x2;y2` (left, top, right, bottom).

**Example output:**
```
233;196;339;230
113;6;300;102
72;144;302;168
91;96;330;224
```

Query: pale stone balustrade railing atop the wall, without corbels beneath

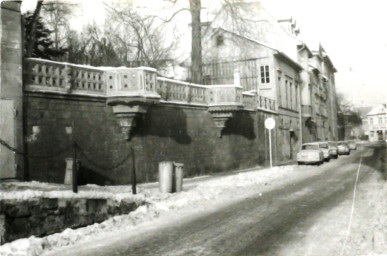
24;58;276;111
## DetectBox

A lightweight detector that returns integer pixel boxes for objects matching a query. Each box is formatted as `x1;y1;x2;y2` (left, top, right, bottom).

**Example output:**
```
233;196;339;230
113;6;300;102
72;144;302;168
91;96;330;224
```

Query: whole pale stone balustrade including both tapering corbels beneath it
24;58;276;139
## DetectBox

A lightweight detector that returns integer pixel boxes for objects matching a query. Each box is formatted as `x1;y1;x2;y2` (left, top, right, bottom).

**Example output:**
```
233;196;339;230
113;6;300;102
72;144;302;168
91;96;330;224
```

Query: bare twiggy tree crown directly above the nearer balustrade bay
106;2;174;69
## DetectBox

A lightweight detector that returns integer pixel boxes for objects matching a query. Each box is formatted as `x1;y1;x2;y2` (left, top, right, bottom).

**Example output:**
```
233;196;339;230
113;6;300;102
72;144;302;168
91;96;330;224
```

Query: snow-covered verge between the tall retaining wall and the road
0;165;321;256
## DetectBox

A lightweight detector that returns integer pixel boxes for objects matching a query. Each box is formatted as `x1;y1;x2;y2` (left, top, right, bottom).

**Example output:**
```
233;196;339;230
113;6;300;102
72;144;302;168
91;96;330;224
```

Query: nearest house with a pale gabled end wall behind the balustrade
203;28;302;161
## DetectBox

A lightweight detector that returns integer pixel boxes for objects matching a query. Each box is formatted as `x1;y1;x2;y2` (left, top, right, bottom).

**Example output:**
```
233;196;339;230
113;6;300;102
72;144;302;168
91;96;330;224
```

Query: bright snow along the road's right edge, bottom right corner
276;172;387;256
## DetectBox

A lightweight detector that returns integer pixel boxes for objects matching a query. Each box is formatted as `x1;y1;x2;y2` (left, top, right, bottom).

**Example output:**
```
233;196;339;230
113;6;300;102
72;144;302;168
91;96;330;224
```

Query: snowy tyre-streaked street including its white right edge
38;144;387;255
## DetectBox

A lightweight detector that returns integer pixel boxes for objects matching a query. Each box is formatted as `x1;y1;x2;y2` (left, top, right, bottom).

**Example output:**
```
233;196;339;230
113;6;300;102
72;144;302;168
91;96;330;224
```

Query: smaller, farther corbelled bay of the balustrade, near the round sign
208;85;243;138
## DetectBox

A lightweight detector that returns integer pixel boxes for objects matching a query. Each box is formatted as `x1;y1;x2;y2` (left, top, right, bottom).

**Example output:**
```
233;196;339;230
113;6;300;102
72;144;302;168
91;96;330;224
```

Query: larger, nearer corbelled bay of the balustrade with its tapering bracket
106;68;160;140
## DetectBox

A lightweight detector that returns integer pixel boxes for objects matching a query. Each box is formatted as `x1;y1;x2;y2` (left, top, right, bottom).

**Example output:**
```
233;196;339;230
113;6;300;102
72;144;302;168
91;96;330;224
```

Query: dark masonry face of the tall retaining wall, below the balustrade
25;93;272;185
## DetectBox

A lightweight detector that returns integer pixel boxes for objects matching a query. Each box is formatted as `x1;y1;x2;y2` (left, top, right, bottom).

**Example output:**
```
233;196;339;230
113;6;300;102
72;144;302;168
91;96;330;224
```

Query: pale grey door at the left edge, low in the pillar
0;100;16;179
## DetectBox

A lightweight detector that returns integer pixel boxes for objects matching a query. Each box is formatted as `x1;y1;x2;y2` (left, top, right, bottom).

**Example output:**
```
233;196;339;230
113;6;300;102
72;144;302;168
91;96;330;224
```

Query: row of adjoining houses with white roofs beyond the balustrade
202;2;338;159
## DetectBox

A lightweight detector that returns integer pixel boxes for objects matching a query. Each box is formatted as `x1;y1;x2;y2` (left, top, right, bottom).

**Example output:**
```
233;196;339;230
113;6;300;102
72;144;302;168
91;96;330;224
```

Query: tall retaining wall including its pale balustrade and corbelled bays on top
24;59;279;185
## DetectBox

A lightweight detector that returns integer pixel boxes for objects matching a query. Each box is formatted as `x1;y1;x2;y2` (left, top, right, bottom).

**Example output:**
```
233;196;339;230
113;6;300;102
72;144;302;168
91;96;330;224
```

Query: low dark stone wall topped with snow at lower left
0;198;144;244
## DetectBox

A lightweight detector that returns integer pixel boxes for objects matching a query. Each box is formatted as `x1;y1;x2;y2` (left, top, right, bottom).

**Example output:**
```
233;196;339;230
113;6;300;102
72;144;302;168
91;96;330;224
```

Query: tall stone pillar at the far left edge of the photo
0;1;24;179
